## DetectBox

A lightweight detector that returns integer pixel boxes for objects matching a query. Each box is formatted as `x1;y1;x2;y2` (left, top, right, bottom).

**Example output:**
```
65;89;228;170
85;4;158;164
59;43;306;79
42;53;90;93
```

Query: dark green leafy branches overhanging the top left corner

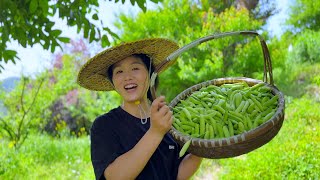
0;0;159;72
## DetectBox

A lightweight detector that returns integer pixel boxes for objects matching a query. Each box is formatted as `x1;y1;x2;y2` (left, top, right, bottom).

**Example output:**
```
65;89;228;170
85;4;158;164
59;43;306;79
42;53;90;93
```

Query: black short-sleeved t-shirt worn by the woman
90;107;182;180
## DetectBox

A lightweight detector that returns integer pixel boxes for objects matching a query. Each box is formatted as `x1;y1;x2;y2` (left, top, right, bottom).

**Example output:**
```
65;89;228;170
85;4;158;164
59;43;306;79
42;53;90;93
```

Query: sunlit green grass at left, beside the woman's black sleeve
0;134;94;179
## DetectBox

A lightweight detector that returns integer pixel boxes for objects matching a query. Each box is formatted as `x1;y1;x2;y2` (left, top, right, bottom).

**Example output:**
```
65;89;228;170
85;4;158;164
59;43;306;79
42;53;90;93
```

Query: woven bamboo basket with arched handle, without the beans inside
151;31;285;159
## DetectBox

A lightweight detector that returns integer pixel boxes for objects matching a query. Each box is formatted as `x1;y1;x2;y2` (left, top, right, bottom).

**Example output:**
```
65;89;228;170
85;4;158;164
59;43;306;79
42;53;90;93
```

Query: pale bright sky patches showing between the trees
0;0;291;81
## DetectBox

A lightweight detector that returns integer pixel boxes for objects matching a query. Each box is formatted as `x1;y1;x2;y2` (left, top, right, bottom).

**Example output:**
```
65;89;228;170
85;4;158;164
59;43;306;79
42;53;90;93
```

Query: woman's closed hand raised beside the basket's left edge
150;96;173;136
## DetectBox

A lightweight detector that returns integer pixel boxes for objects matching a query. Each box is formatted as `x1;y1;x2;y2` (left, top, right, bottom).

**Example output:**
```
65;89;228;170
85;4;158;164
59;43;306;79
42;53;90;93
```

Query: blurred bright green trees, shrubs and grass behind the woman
0;0;320;179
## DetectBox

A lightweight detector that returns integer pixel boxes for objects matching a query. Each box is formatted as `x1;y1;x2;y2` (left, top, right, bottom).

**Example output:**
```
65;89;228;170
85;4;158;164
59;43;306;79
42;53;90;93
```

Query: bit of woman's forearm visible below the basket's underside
177;154;202;180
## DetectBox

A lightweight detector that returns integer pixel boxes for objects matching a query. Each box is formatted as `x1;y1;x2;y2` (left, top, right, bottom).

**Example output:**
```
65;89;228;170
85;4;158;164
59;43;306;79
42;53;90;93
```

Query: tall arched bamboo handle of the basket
150;31;274;100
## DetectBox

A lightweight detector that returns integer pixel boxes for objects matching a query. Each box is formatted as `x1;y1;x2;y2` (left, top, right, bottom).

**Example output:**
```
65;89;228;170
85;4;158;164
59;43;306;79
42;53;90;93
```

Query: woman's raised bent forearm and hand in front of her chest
104;97;172;180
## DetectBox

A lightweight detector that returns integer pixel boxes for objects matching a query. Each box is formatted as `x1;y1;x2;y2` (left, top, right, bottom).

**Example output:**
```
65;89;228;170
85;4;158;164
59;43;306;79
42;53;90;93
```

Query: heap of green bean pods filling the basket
173;82;279;139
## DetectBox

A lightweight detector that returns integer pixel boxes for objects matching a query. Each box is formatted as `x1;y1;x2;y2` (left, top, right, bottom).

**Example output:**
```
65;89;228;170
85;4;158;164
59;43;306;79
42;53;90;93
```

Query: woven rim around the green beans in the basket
169;77;285;148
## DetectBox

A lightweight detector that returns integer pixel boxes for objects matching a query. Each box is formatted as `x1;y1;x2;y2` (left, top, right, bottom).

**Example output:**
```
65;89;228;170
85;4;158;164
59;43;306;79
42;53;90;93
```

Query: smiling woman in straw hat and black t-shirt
78;38;202;180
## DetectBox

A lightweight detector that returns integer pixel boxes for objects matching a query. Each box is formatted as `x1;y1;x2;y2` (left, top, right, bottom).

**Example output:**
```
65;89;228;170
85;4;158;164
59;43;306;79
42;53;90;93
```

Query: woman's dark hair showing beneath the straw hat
107;54;159;101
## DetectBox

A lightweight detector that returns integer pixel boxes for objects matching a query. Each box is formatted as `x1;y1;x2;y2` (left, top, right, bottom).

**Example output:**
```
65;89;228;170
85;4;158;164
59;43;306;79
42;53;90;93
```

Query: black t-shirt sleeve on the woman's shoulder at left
90;117;121;180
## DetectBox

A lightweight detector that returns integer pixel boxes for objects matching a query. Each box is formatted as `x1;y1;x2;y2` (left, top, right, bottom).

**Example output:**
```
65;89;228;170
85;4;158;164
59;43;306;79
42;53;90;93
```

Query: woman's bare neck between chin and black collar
121;100;151;119
